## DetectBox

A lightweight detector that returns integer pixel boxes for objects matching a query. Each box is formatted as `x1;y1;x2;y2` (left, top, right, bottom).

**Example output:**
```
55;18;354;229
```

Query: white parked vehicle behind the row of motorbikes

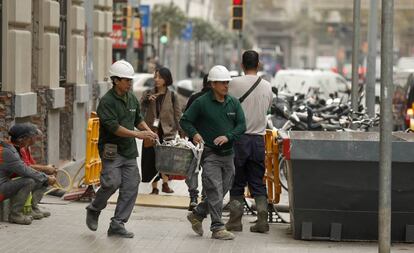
272;69;351;101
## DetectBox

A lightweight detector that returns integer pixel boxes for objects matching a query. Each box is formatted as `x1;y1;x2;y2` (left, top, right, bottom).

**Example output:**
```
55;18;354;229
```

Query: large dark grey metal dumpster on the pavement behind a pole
283;132;414;242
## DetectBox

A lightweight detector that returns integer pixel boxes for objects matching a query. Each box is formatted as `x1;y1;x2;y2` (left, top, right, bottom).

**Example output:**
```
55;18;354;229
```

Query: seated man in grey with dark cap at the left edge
0;124;56;225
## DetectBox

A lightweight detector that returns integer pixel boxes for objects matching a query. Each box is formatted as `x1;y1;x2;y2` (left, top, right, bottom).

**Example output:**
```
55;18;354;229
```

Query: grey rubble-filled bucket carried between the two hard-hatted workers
154;144;194;176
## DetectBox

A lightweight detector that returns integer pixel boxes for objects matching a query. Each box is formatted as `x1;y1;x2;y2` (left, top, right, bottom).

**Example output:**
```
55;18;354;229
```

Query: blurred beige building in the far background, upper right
247;0;414;68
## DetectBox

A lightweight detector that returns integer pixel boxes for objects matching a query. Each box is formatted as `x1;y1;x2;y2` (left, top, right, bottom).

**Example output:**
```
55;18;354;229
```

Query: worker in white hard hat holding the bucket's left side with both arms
86;60;158;238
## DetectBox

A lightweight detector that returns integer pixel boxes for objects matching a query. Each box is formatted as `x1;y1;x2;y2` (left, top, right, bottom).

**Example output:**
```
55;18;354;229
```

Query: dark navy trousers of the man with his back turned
230;134;267;197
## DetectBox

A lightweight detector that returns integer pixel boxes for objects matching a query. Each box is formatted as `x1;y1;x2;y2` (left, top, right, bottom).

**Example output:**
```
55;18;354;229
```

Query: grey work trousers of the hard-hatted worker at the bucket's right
193;147;234;231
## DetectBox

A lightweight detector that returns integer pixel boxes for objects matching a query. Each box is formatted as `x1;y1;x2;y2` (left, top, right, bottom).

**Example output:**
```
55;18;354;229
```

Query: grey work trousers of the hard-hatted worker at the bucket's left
87;154;141;225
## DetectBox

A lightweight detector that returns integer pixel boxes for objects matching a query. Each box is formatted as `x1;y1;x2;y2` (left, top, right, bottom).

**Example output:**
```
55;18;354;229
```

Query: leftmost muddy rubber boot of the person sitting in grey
9;180;34;225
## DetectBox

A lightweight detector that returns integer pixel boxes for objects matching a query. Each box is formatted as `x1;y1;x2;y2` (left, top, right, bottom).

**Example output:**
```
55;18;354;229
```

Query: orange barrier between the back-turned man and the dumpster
264;130;282;204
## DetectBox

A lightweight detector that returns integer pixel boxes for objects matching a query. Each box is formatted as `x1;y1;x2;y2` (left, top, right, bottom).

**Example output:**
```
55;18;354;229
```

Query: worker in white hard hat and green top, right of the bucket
180;65;246;240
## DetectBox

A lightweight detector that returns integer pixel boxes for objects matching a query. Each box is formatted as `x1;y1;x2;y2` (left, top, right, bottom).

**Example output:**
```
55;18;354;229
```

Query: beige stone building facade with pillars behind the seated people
0;0;112;170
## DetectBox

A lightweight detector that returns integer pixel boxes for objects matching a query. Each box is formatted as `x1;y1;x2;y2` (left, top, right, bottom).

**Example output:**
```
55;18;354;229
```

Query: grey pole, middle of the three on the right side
366;0;378;118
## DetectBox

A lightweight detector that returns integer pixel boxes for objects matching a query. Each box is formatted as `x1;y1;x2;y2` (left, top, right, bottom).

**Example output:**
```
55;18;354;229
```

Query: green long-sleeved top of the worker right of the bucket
180;91;246;156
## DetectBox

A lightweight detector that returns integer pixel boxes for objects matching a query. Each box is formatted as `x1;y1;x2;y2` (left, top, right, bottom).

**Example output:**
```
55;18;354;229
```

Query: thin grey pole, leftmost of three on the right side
351;0;361;112
